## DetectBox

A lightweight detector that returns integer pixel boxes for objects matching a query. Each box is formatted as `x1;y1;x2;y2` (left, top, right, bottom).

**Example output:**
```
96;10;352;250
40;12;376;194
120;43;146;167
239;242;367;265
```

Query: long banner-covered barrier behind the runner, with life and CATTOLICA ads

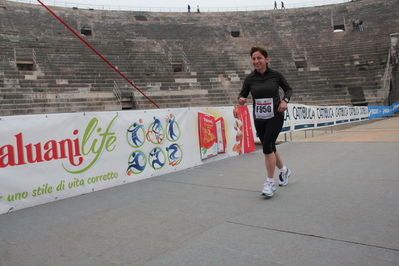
0;103;399;214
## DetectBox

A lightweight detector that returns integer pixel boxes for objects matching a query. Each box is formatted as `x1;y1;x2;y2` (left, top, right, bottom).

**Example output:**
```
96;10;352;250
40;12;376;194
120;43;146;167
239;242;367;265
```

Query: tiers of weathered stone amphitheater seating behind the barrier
0;0;399;115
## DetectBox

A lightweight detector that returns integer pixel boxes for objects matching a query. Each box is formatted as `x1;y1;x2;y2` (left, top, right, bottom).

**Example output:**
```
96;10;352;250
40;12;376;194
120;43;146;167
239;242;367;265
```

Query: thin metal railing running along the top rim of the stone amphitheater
8;0;350;12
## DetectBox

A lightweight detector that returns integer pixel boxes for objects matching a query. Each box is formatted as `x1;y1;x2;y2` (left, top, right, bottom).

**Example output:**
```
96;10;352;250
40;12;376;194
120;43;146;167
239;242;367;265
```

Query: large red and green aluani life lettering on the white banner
0;115;118;174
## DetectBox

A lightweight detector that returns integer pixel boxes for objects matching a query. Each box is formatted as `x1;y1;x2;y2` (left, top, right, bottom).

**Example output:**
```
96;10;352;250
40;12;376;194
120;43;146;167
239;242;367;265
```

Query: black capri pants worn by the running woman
254;113;284;154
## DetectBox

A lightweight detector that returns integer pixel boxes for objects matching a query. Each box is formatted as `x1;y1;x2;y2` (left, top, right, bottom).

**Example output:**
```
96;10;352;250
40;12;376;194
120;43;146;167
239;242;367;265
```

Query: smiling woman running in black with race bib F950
238;46;292;197
